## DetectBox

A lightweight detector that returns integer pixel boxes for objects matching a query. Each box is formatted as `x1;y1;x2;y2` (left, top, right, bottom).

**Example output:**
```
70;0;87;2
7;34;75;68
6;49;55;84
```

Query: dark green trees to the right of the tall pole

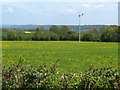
81;26;119;42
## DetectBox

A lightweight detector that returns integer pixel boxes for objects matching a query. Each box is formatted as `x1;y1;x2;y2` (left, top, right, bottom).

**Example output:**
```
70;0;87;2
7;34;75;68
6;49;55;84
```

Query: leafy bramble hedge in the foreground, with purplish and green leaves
2;57;120;89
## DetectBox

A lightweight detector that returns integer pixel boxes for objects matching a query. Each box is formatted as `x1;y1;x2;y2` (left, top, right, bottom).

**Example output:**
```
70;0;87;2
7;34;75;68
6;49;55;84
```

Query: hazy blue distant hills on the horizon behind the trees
2;25;108;32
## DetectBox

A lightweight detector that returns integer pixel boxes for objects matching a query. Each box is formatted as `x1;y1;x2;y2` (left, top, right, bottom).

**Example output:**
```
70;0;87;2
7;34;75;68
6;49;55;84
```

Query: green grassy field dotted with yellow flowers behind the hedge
2;41;118;73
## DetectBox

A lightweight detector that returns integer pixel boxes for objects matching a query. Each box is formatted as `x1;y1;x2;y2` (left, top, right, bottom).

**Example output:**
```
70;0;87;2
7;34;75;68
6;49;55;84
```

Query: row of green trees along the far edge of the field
2;25;120;42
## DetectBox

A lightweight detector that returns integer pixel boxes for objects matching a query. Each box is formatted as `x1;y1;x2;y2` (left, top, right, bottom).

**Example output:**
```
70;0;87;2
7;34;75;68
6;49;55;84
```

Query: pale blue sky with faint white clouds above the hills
0;0;118;25
